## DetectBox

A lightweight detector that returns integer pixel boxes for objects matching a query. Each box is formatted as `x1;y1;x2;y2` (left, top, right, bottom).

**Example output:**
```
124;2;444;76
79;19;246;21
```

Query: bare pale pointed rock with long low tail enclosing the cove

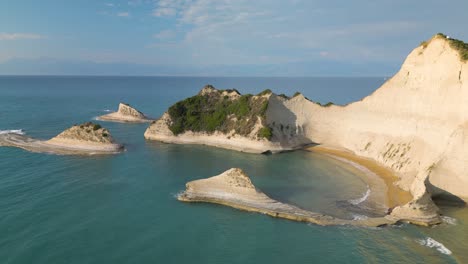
178;168;398;227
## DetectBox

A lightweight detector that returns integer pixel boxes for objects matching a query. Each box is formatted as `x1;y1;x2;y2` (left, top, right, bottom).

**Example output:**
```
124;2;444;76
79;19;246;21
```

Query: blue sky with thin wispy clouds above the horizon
0;0;468;76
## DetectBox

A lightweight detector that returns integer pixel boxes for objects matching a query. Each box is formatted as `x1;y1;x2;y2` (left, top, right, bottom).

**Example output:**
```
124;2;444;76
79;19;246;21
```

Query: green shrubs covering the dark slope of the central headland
168;86;271;139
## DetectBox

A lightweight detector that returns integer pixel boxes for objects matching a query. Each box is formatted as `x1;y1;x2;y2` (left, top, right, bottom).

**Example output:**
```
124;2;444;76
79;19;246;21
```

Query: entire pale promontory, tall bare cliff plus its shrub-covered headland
168;34;468;225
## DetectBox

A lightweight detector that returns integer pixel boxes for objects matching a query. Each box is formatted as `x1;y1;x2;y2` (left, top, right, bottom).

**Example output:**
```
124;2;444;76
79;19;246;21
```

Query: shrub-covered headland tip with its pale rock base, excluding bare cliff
145;85;310;153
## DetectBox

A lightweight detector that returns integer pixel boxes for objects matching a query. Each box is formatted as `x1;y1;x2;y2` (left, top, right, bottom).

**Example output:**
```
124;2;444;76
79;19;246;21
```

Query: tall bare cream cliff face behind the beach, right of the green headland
267;36;468;204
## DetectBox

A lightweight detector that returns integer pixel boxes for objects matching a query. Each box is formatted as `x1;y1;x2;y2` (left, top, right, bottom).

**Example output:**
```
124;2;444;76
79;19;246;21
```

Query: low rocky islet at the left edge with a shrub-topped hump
0;122;123;155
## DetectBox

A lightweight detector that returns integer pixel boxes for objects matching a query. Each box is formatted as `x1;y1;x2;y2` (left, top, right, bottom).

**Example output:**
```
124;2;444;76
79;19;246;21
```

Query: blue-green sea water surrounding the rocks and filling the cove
0;76;468;264
